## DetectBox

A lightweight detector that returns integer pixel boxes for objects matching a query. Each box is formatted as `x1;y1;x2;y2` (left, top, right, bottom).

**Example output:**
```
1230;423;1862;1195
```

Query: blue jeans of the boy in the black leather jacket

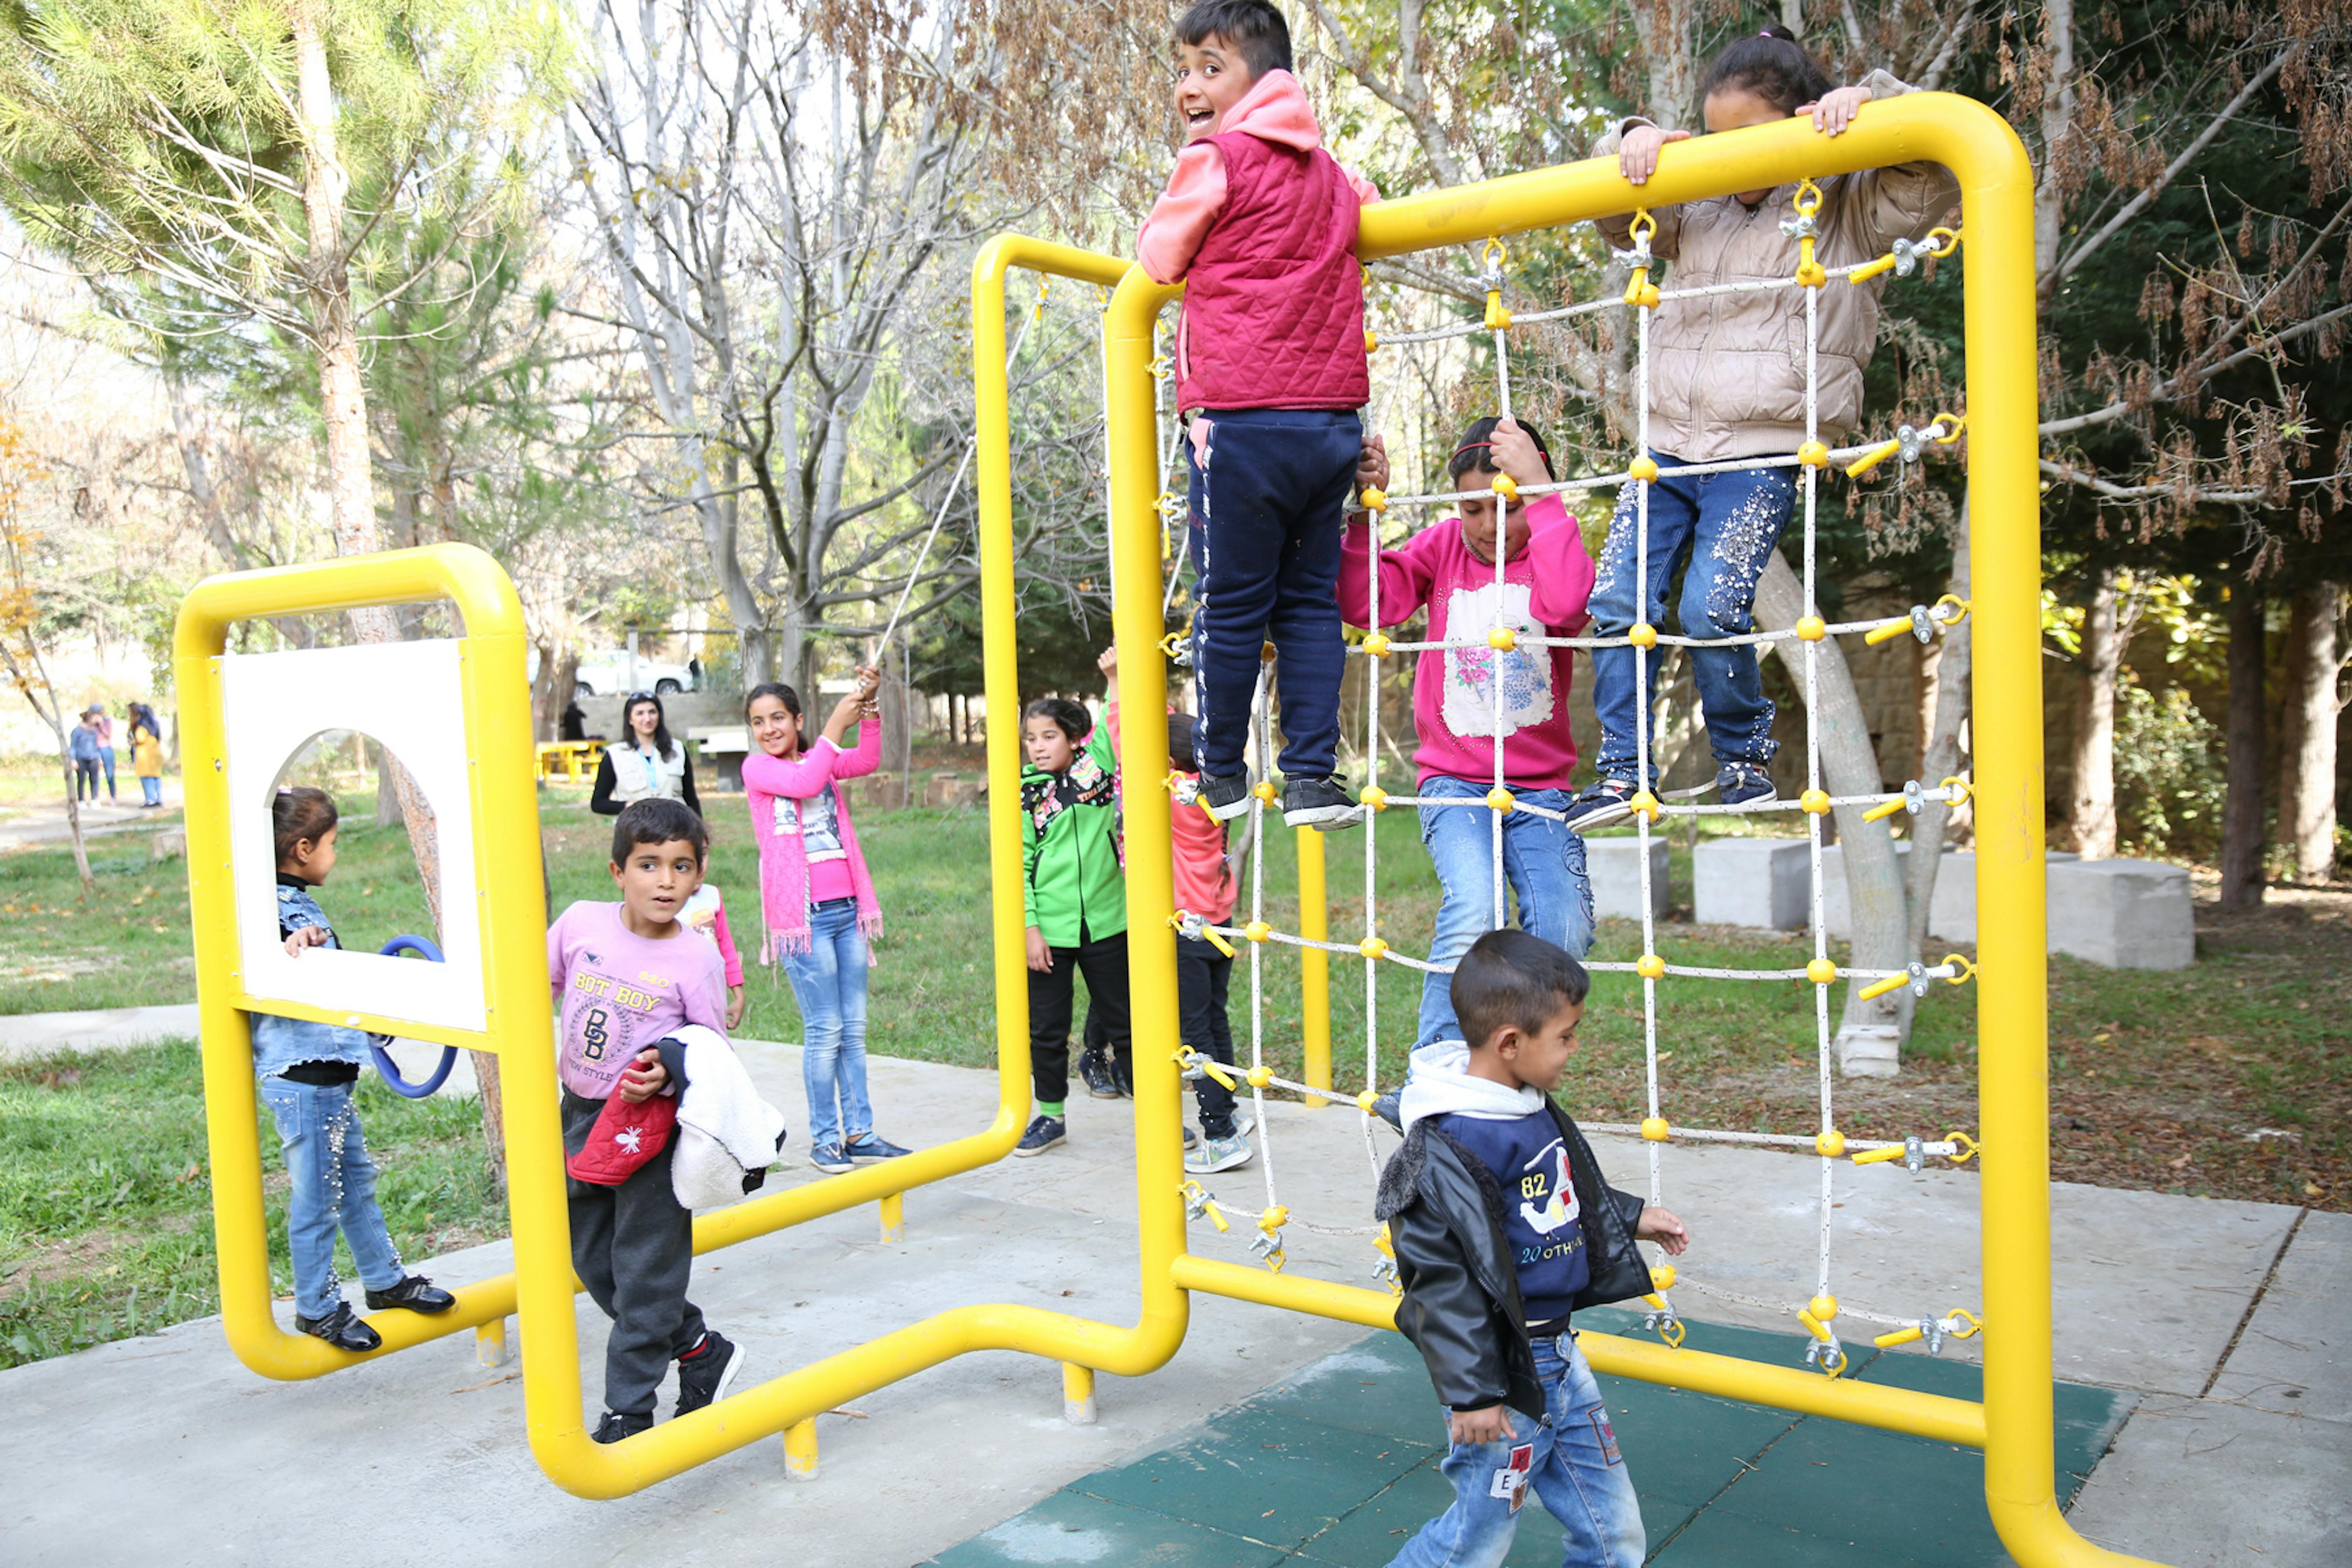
1390;1335;1649;1568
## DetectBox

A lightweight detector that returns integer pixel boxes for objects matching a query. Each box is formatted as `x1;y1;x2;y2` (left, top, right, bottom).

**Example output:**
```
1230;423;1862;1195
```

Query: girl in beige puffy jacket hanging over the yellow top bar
1569;26;1959;832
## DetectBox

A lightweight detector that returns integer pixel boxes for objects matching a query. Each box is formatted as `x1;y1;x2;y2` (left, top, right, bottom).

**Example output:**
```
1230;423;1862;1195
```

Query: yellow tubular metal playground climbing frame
174;94;2136;1568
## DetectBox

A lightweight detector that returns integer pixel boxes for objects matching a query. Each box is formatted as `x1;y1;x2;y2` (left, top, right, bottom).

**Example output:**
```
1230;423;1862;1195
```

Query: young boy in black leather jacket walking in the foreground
1376;931;1689;1568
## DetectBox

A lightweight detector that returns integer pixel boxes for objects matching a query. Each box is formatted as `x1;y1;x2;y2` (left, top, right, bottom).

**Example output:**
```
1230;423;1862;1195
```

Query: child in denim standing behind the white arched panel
252;790;456;1354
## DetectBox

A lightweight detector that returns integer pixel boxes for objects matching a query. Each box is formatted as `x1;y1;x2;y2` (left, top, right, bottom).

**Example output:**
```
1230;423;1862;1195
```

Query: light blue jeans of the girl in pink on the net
1413;778;1592;1046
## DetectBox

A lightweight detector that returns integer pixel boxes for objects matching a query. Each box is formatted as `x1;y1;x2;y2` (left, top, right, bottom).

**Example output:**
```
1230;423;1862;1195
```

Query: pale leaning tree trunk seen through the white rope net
1757;550;1912;1077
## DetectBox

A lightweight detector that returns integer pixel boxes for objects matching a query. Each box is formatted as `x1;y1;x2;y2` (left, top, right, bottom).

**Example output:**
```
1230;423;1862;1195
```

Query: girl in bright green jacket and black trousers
1014;696;1134;1156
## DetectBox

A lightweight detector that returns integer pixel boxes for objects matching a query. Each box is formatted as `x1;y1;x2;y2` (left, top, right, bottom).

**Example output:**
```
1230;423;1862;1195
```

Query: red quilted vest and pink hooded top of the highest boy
1136;71;1381;409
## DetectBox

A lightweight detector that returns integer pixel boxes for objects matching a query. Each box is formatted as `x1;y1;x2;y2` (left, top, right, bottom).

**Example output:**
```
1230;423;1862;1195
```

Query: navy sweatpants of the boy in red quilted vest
1186;409;1364;778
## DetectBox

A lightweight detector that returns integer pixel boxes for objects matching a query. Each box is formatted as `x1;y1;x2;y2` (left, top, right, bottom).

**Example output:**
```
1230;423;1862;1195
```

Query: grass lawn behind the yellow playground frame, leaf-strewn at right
0;790;2352;1363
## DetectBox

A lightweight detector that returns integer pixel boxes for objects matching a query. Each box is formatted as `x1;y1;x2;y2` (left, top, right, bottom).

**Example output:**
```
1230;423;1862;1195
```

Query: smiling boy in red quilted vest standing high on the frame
1136;0;1381;830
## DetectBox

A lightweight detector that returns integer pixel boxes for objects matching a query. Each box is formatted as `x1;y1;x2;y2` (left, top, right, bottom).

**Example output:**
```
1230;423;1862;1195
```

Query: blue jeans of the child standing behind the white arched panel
261;1079;402;1319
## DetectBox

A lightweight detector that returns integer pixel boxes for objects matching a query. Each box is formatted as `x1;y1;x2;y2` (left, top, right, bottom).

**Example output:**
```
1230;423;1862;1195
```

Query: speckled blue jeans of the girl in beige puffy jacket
1590;451;1797;785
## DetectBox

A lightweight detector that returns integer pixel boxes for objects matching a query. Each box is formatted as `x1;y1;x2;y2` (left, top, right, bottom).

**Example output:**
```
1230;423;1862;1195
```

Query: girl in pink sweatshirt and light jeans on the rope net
1338;419;1592;1046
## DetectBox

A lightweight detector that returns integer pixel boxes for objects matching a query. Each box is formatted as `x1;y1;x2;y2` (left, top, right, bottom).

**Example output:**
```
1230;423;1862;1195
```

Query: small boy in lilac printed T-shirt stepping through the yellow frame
548;797;743;1443
